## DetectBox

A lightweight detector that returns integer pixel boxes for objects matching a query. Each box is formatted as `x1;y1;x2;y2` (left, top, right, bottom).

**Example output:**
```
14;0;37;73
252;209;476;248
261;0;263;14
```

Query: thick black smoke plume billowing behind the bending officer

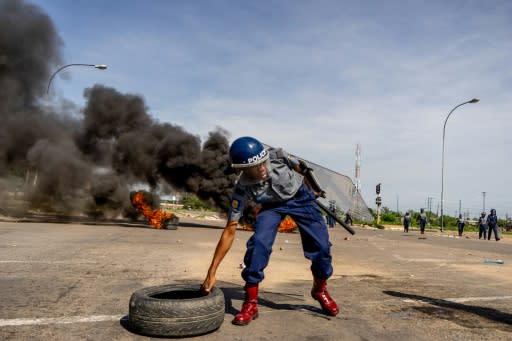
0;0;233;216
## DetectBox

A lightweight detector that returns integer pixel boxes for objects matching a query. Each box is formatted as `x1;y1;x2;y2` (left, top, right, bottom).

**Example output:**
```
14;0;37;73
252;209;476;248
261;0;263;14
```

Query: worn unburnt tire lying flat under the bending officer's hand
128;284;225;337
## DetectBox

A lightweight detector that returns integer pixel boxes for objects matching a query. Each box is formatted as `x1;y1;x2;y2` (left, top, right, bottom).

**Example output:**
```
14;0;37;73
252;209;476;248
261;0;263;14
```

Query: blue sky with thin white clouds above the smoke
32;0;512;217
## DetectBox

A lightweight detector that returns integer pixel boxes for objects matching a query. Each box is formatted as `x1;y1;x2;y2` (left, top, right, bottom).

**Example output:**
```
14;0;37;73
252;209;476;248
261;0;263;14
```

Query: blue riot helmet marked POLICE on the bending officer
229;136;268;168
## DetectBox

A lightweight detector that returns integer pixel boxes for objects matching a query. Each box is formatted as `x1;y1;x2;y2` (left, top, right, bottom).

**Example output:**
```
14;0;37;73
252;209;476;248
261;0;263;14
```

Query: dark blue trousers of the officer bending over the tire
242;186;333;284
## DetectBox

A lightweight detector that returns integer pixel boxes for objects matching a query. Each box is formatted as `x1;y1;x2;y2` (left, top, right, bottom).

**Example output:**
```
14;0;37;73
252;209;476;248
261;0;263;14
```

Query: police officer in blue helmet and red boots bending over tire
202;136;339;325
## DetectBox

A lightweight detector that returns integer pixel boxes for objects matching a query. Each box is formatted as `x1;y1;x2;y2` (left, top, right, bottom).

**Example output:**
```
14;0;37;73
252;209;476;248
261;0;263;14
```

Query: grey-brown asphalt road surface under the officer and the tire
0;219;512;340
